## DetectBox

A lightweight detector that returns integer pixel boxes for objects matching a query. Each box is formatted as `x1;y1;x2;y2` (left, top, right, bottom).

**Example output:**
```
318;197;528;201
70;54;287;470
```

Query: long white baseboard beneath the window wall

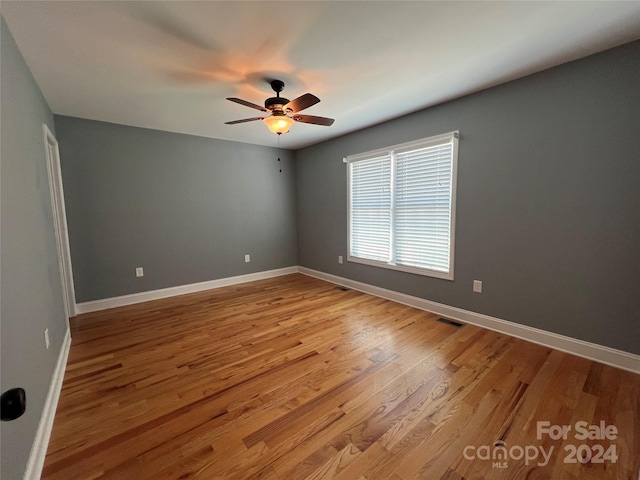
298;267;640;373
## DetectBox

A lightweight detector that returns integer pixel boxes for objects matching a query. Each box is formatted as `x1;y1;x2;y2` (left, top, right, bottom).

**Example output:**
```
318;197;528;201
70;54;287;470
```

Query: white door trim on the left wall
42;123;76;318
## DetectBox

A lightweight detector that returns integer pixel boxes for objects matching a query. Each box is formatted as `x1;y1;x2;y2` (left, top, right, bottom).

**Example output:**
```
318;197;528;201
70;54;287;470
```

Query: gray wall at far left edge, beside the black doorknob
0;19;67;480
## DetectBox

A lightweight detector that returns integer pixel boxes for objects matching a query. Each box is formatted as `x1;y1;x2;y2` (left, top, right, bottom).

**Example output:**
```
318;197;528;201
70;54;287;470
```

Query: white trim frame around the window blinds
344;130;460;281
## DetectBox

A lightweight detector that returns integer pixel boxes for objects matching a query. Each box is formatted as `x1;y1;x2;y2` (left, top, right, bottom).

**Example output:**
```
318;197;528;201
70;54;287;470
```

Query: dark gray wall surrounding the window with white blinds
296;42;640;353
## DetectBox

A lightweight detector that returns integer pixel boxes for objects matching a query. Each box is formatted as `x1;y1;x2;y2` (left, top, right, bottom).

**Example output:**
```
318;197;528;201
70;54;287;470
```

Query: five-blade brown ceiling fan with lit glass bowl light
225;80;334;135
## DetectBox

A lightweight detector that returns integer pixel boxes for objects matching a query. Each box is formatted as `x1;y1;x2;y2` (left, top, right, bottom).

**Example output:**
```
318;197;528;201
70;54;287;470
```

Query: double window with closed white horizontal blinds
346;132;458;280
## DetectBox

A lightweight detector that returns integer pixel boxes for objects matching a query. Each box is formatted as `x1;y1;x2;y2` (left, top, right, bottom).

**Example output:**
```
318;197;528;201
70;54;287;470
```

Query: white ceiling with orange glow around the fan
1;0;640;149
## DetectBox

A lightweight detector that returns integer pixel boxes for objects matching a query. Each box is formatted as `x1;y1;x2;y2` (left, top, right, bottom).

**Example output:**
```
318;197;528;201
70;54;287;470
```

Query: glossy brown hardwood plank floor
43;274;640;480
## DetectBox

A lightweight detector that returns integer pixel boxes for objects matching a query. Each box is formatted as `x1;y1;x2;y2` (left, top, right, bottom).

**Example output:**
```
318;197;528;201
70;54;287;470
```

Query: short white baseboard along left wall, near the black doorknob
23;328;71;480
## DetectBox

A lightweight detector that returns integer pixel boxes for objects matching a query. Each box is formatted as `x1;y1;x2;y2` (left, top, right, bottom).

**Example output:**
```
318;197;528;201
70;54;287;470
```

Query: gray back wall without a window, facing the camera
55;116;297;302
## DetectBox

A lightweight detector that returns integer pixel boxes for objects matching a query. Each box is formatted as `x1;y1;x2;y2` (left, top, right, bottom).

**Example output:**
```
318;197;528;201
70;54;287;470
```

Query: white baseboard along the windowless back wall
76;267;298;314
